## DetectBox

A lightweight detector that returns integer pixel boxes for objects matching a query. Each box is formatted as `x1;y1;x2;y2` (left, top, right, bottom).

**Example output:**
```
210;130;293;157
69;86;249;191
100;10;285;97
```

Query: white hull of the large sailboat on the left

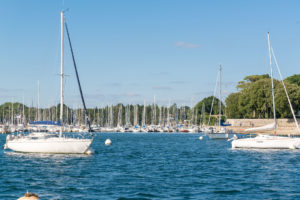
6;138;93;154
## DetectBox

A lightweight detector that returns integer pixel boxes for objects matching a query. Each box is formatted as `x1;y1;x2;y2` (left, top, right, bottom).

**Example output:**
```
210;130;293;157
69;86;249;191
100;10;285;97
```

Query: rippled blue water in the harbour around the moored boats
0;133;300;200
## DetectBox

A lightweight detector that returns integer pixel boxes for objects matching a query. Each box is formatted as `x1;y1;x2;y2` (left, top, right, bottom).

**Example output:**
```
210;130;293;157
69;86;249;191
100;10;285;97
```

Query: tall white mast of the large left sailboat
59;11;64;137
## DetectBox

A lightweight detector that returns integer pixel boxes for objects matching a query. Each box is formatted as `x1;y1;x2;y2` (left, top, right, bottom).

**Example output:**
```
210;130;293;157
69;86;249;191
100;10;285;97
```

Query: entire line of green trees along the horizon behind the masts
0;74;300;126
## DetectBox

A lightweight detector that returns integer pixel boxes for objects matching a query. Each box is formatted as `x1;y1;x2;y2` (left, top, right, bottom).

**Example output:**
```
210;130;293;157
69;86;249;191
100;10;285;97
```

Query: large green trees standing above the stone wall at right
225;74;300;119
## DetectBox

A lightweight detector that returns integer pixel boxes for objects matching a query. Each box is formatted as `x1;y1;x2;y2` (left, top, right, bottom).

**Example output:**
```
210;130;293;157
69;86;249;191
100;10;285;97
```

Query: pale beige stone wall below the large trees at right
226;119;300;135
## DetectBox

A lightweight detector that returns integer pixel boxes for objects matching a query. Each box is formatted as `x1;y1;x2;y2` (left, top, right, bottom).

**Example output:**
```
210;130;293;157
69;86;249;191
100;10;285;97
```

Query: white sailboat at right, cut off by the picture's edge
232;33;300;149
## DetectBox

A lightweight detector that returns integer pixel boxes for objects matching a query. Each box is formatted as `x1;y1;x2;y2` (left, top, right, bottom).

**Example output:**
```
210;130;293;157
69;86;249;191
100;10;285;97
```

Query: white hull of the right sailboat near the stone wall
232;135;300;149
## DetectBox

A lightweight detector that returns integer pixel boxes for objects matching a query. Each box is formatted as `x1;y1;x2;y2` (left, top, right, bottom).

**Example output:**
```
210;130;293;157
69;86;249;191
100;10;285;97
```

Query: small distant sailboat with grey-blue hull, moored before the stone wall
208;65;235;139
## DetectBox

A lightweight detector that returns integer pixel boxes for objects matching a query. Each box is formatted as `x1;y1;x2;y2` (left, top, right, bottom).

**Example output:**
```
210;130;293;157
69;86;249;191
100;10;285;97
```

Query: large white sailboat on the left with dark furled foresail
5;12;93;154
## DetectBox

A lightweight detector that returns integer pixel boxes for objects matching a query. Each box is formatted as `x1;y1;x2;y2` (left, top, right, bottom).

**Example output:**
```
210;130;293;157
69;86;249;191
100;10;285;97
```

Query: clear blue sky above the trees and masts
0;0;300;107
